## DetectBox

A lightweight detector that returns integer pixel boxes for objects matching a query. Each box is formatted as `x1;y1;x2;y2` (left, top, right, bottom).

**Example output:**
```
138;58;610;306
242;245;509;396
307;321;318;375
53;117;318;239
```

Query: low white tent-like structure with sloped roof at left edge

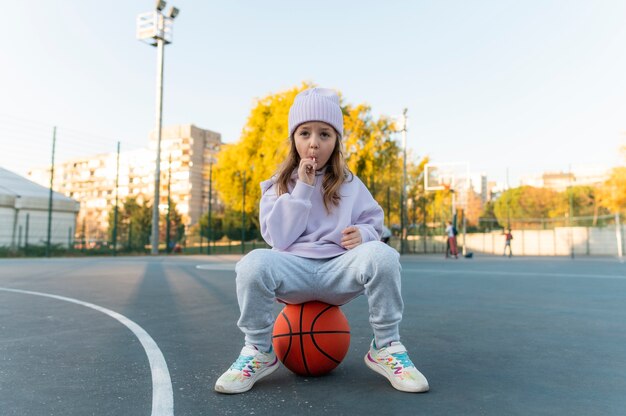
0;168;80;249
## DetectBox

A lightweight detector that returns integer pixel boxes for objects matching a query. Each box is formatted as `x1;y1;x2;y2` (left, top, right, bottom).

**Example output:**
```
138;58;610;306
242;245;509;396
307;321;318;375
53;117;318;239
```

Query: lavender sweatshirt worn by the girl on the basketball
259;171;384;259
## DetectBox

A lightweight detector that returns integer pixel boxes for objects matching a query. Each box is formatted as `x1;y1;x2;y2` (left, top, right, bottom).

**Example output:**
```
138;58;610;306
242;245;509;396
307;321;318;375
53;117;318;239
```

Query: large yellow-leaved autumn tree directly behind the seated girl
214;83;425;234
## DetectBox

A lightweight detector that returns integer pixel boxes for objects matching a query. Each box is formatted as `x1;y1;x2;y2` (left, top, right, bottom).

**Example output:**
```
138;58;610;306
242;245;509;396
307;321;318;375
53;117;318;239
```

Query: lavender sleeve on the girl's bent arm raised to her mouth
259;180;315;250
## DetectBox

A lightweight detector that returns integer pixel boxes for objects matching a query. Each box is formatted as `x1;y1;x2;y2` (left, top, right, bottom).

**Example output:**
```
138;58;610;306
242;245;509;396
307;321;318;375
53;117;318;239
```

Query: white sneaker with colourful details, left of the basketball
215;345;279;394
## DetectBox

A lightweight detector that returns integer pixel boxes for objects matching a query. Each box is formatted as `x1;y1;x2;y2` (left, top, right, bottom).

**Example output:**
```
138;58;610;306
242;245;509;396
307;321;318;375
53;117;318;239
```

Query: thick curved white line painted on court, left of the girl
0;287;174;416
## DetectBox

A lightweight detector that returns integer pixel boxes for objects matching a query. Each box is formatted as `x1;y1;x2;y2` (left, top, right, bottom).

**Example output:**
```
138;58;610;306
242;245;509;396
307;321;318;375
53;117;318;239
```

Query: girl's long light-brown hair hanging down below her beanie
276;131;352;213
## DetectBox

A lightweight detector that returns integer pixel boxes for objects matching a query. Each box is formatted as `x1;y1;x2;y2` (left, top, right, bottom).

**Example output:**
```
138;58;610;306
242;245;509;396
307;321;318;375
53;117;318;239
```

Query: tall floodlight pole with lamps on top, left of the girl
137;0;180;255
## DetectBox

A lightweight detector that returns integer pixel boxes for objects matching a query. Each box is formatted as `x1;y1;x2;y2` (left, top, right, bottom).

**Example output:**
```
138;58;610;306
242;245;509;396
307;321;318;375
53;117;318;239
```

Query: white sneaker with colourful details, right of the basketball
365;341;429;393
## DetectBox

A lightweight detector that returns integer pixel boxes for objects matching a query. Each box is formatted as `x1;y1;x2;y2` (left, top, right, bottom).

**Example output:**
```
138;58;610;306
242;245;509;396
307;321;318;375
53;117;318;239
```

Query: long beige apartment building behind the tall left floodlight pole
28;124;221;240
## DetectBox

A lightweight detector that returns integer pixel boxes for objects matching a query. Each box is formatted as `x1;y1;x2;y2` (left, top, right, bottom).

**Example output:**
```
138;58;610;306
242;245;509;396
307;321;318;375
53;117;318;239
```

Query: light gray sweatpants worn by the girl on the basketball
235;241;404;351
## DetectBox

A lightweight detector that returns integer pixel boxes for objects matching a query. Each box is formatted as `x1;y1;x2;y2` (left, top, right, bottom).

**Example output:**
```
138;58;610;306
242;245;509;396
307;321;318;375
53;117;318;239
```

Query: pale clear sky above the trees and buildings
0;0;626;184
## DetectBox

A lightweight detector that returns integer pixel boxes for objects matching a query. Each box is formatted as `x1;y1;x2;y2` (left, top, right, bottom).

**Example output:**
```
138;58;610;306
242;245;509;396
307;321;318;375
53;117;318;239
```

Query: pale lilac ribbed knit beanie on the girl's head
289;88;343;137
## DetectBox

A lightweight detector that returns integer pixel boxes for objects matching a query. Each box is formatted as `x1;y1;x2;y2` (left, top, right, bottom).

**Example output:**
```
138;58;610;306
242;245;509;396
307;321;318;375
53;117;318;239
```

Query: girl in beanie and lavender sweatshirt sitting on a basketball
215;88;428;393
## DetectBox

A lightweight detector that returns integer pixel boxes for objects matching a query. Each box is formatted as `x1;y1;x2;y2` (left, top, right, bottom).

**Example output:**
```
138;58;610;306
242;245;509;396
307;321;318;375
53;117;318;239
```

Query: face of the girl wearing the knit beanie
293;121;337;169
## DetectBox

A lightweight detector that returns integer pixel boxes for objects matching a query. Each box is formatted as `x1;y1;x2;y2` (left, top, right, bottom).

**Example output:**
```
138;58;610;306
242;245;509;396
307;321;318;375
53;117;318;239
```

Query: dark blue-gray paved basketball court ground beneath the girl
0;252;626;416
